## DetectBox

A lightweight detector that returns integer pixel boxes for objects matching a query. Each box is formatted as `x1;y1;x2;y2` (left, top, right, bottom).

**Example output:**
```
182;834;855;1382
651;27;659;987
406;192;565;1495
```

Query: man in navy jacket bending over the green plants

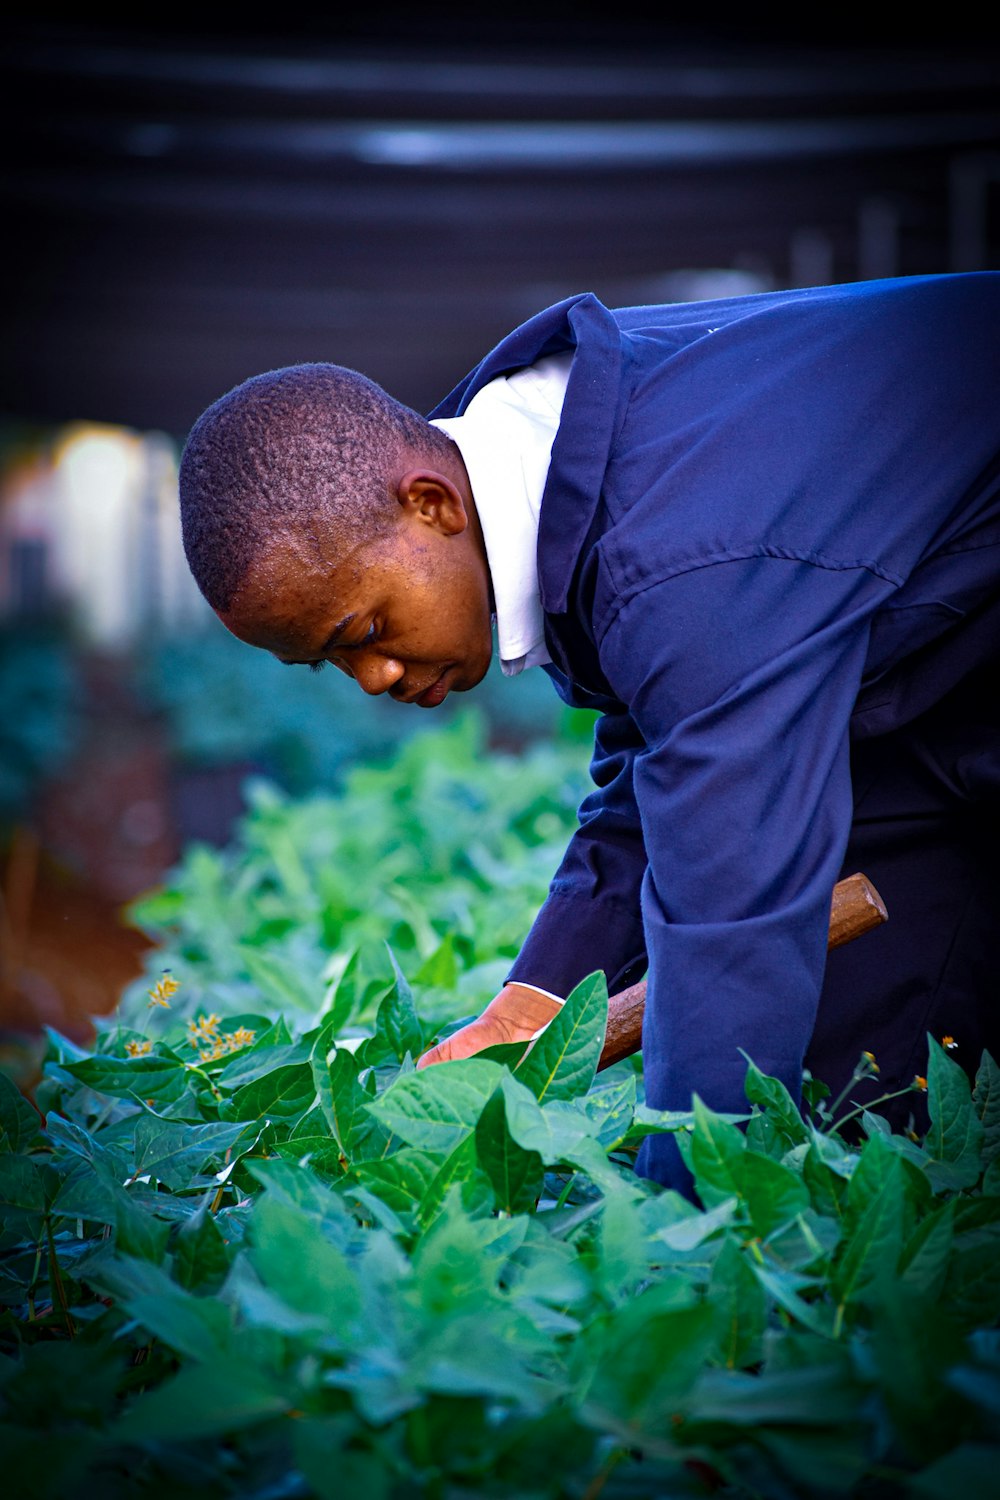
180;273;1000;1184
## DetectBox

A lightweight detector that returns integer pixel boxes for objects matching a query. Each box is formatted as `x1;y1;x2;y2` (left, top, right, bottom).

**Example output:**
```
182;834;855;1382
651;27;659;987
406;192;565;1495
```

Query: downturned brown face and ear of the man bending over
219;480;493;708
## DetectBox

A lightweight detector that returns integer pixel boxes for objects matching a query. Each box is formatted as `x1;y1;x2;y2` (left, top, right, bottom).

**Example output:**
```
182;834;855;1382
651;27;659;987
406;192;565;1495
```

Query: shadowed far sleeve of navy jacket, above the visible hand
508;705;646;995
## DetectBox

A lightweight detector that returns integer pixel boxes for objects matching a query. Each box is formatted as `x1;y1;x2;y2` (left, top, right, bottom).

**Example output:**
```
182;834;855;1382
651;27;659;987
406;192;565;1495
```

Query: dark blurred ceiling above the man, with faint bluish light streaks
7;19;1000;435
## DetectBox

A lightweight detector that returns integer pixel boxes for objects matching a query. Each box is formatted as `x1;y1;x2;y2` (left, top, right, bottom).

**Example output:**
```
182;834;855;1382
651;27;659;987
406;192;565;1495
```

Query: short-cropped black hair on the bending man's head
180;363;451;611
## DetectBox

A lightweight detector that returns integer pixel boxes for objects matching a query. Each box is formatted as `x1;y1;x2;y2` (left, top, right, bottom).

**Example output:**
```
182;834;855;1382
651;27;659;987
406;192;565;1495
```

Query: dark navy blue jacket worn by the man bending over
433;273;1000;1176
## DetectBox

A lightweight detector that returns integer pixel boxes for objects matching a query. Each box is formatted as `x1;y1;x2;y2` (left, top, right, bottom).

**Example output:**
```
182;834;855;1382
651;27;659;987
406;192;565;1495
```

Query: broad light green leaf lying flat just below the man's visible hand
367;1058;504;1157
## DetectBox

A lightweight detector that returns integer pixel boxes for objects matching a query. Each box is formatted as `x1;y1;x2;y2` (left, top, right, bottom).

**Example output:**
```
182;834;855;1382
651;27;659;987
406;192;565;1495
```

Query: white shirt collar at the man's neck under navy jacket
433;353;573;677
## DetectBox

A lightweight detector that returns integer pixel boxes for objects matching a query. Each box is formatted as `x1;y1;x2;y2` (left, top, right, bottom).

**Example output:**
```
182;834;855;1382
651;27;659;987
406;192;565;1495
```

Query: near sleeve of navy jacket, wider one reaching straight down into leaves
601;555;888;1158
